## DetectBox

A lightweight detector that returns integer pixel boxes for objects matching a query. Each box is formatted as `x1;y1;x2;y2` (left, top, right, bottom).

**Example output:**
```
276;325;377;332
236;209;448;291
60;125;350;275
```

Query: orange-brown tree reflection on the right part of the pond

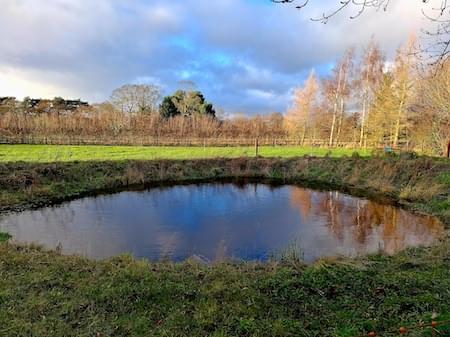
291;187;443;253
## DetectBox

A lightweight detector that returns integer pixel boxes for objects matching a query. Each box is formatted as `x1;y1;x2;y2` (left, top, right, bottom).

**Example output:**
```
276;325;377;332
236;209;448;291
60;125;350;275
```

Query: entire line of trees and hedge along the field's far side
0;36;450;154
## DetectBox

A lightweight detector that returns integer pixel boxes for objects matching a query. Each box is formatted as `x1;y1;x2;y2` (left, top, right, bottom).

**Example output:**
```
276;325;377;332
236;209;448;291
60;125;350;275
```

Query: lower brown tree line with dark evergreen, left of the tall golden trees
0;84;286;143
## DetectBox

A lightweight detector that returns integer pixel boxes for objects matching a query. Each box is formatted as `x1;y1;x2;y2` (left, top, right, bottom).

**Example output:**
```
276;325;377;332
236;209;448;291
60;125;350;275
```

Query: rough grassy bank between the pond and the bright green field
0;156;450;224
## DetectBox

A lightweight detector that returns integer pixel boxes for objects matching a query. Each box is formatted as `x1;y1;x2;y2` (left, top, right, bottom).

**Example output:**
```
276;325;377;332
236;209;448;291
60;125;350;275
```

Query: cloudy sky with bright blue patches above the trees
0;0;436;115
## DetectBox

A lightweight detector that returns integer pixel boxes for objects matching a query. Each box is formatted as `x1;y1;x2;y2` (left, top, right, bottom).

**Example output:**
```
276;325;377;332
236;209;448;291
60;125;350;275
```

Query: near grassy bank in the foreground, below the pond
0;243;450;337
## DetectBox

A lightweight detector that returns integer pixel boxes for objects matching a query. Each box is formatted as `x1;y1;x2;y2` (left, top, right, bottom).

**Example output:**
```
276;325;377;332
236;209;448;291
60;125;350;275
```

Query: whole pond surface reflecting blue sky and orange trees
0;184;444;262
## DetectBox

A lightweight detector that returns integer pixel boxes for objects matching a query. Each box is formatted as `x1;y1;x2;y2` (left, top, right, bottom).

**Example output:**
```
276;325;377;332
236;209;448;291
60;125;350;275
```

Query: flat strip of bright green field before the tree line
0;145;370;163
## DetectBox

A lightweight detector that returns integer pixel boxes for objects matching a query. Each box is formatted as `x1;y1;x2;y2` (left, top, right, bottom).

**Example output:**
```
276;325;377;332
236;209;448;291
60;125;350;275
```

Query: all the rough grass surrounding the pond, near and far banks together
0;155;450;337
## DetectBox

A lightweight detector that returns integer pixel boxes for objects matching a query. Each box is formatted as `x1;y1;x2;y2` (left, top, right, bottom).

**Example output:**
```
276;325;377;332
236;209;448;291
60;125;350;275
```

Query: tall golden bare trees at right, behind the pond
285;36;450;153
